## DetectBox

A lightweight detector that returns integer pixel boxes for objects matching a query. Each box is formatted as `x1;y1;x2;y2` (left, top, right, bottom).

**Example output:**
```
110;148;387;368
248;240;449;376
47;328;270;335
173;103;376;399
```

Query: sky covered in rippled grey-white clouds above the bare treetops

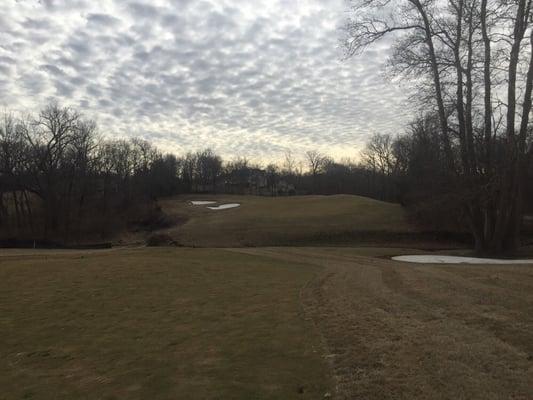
0;0;409;161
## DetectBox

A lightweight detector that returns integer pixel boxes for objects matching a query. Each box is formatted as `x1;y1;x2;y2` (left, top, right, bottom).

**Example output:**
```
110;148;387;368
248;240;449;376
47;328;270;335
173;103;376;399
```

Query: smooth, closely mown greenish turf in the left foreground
0;249;331;400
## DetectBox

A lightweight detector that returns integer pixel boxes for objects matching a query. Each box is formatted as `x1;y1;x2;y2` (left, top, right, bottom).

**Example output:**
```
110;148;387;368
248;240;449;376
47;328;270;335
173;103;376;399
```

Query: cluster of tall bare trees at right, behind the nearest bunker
345;0;533;253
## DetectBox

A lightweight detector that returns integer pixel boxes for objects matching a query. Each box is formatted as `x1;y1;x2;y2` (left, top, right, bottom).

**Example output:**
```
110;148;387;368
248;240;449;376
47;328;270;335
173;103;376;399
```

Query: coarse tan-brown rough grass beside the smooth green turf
231;248;533;400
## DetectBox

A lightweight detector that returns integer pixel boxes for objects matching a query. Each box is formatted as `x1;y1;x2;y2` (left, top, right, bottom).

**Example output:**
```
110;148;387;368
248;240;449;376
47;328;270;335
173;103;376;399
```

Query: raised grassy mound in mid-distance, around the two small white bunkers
160;195;413;247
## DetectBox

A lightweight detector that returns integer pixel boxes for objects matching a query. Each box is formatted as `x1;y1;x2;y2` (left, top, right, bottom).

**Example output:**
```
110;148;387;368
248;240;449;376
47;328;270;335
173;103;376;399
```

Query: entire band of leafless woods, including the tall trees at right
0;0;533;253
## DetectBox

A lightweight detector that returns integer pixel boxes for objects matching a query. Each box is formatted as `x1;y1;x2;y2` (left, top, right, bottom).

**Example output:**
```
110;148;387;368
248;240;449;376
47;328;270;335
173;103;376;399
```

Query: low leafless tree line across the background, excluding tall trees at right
0;104;533;248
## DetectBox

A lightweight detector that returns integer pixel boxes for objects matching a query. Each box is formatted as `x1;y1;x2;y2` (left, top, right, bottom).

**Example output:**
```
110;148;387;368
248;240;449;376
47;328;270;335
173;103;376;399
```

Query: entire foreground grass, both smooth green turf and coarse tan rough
0;247;533;400
